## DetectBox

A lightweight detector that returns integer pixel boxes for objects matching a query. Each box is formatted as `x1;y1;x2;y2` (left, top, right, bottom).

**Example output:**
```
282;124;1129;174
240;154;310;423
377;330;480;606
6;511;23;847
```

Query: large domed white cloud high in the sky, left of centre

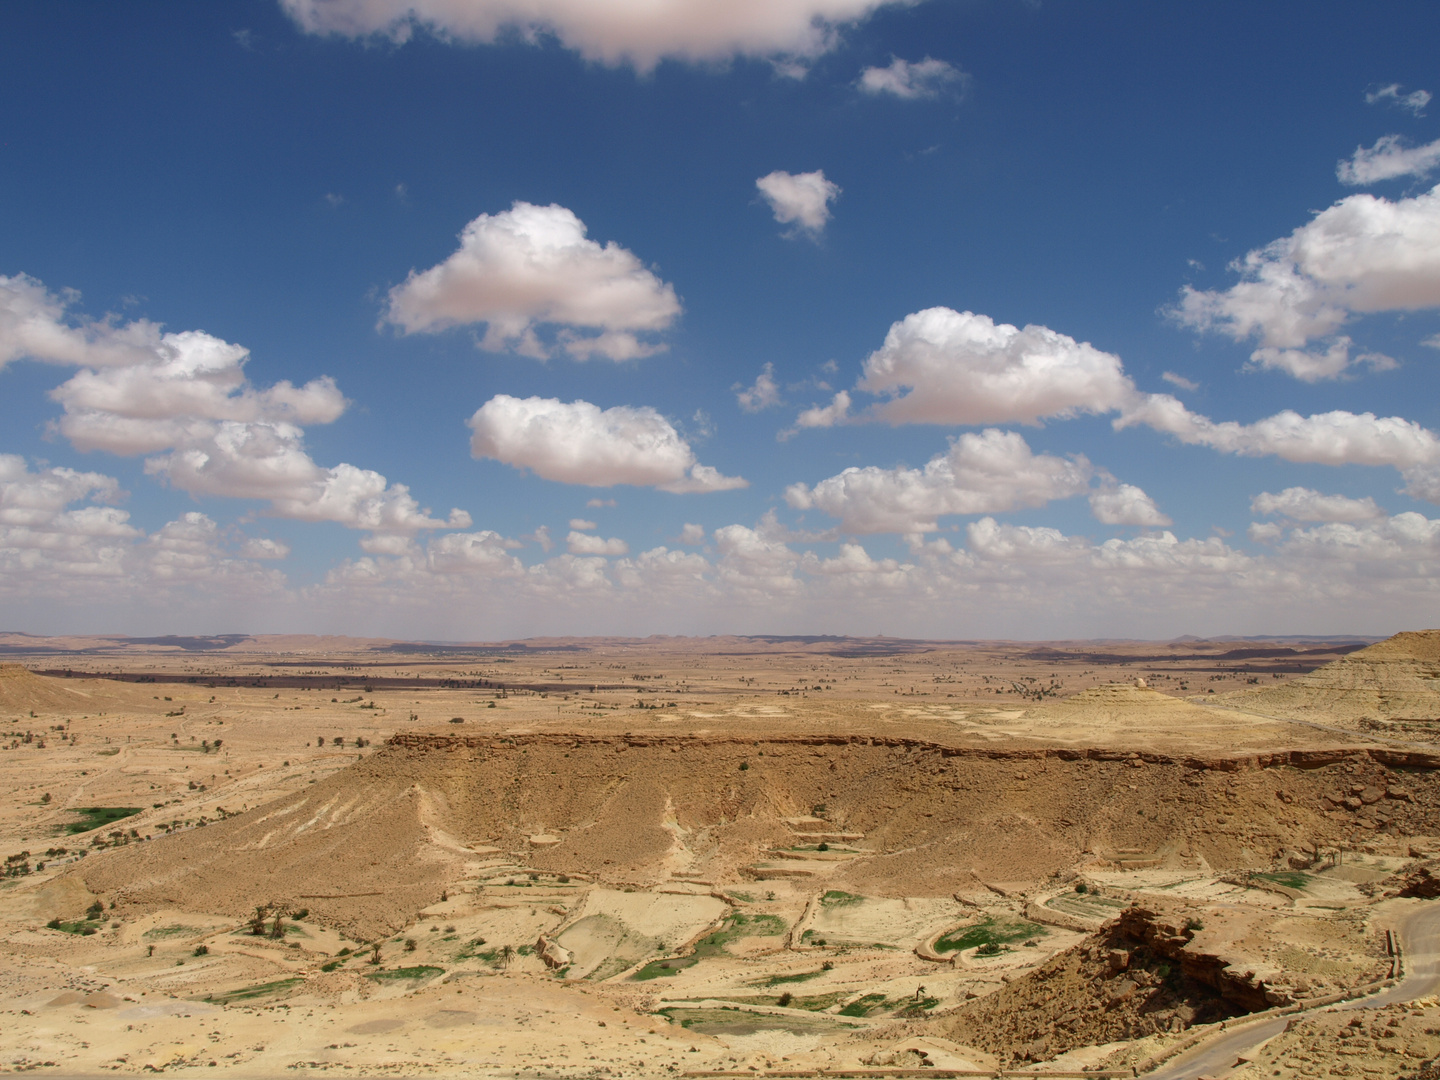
386;202;680;360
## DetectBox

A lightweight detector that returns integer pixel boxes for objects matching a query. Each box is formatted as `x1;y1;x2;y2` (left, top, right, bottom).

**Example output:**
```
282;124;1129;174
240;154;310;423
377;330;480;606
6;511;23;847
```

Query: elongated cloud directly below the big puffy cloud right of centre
785;428;1088;533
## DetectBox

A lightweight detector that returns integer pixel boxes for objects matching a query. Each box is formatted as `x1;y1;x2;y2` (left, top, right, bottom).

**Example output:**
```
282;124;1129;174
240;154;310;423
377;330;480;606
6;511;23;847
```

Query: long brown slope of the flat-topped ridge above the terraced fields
75;734;1440;937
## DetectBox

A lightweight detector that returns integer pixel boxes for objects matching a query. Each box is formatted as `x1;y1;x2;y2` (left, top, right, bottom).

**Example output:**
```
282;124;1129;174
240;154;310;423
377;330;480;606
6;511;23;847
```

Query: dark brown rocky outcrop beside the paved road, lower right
946;907;1290;1061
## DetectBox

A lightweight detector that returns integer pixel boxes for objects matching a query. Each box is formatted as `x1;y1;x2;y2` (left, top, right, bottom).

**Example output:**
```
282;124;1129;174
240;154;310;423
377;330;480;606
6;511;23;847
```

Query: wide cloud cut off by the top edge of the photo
281;0;912;72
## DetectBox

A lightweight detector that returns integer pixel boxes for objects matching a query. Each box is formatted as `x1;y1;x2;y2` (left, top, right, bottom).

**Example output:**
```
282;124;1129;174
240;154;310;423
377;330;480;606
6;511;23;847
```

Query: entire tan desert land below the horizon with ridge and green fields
0;631;1440;1080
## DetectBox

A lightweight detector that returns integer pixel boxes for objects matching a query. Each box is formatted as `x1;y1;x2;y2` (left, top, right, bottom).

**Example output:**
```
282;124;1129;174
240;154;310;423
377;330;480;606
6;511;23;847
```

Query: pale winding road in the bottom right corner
1146;903;1440;1080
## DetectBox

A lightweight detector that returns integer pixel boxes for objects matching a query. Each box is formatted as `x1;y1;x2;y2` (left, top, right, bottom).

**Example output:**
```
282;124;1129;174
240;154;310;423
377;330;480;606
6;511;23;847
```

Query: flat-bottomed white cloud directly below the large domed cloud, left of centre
469;395;749;494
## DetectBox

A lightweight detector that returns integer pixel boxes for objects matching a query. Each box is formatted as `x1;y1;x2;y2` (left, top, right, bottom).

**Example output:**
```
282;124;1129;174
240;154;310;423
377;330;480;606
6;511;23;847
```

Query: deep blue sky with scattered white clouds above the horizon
0;0;1440;639
